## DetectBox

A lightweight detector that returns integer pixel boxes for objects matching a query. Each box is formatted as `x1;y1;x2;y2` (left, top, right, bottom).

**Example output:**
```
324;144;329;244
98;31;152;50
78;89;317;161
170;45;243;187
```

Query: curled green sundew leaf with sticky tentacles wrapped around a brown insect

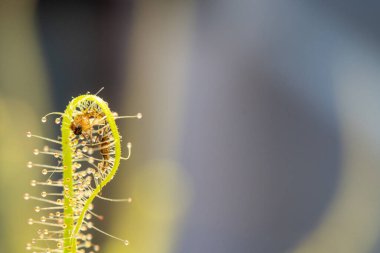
24;88;142;253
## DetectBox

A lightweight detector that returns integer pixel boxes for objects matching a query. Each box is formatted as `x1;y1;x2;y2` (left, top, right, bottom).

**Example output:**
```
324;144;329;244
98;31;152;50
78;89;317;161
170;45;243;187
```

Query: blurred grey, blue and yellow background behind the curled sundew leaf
0;0;380;253
